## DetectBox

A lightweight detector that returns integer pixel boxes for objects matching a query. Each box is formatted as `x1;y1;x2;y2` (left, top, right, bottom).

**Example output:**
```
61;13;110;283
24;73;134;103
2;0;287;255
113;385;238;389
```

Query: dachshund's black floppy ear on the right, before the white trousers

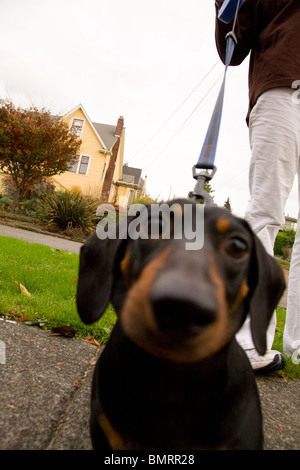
249;234;285;354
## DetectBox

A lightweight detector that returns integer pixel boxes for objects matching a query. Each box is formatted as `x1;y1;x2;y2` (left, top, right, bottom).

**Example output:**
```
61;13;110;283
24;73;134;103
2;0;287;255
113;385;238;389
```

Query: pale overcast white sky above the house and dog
0;0;298;218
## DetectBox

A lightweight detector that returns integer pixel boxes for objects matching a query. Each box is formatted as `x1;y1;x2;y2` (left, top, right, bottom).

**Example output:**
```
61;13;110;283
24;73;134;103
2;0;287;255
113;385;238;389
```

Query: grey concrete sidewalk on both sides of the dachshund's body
0;320;300;450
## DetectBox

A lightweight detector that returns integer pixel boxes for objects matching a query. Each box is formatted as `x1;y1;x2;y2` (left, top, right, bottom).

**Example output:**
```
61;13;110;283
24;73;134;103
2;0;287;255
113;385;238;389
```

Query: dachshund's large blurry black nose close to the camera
149;276;218;336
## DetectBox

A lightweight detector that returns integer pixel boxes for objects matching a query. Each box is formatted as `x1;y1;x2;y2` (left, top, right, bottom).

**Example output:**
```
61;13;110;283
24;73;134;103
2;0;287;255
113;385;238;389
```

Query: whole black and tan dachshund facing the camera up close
77;200;285;451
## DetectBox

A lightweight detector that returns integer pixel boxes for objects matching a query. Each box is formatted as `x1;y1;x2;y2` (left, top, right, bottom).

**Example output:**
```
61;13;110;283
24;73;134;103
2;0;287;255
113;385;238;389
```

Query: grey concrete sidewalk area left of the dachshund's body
0;321;97;450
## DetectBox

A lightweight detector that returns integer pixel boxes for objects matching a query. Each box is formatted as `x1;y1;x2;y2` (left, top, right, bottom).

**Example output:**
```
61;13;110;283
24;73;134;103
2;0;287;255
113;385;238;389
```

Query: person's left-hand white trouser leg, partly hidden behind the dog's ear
237;88;300;349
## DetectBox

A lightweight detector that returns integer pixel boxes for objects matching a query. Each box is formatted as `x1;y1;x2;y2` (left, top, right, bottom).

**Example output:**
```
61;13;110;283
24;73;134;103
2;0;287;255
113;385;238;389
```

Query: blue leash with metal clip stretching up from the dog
189;0;243;205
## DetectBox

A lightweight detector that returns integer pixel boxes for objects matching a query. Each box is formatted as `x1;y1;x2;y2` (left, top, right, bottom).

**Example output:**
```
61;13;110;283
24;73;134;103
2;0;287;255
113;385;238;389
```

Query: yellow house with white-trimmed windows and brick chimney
0;104;143;207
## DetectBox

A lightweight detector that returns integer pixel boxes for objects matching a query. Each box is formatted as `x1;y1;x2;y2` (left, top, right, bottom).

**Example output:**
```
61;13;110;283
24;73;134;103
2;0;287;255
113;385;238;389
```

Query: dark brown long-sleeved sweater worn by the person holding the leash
216;0;300;123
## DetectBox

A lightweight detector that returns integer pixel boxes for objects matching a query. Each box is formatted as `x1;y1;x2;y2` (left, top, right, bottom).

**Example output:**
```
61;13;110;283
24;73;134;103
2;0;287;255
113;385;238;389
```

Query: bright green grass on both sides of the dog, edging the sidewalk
0;237;300;379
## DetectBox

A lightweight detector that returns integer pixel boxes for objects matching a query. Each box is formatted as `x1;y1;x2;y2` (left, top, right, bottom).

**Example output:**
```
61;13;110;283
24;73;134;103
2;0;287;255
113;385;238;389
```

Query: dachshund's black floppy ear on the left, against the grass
76;234;121;324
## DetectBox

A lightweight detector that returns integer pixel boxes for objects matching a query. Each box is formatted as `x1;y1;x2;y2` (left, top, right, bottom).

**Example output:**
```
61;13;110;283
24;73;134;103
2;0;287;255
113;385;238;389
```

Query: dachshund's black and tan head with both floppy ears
77;200;285;362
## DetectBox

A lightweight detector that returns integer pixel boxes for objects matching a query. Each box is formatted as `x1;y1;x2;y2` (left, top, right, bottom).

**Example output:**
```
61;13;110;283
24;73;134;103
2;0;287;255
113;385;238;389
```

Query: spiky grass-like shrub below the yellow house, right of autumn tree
38;191;99;233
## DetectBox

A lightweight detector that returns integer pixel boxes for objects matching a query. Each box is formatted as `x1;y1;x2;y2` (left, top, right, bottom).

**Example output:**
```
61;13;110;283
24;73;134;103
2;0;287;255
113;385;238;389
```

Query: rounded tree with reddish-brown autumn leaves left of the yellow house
0;101;81;207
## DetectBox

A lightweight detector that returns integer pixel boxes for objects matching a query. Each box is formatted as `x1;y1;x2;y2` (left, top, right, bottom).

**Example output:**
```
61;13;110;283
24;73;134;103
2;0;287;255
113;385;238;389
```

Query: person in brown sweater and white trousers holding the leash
215;0;300;373
